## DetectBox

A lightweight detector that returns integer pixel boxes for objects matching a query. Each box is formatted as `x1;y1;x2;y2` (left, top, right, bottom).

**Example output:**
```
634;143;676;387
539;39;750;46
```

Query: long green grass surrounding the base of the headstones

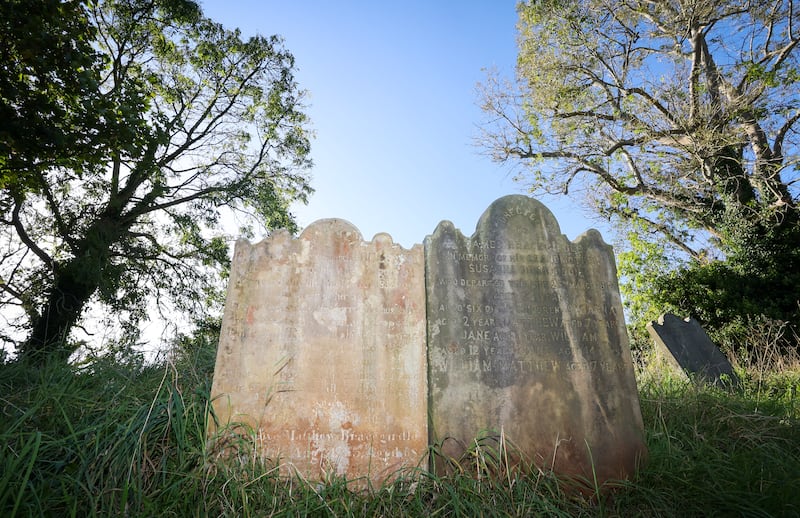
0;344;800;517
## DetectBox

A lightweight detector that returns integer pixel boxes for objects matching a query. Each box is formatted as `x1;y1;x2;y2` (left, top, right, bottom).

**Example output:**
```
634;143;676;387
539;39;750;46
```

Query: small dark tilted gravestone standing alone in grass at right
647;313;739;387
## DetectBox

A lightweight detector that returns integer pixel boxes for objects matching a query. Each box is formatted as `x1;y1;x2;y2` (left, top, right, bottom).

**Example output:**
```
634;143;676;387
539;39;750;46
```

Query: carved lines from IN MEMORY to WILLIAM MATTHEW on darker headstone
436;248;623;378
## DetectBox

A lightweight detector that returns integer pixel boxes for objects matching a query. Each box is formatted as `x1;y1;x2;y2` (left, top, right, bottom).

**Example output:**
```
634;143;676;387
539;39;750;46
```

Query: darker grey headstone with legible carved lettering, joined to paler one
425;195;646;483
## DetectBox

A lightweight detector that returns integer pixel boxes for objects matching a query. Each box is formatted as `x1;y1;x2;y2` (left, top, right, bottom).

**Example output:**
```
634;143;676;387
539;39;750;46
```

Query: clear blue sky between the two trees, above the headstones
200;0;610;248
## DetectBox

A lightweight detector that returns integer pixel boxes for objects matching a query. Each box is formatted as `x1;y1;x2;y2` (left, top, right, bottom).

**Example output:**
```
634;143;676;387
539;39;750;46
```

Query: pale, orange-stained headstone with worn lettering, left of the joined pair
212;219;427;484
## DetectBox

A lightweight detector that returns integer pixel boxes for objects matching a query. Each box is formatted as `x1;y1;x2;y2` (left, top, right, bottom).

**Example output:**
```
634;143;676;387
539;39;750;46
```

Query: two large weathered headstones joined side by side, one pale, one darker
212;195;645;490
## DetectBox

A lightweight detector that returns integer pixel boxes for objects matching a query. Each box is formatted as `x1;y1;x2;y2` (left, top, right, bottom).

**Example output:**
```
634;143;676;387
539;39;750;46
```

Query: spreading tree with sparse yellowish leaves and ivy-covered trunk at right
482;0;800;346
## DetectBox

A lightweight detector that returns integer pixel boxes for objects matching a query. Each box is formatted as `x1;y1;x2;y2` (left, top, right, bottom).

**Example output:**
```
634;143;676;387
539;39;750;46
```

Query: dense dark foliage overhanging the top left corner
0;0;112;196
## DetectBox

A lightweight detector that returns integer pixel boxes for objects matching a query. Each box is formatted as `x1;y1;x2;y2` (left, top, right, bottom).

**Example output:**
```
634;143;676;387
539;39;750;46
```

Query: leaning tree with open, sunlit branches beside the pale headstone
0;0;310;361
